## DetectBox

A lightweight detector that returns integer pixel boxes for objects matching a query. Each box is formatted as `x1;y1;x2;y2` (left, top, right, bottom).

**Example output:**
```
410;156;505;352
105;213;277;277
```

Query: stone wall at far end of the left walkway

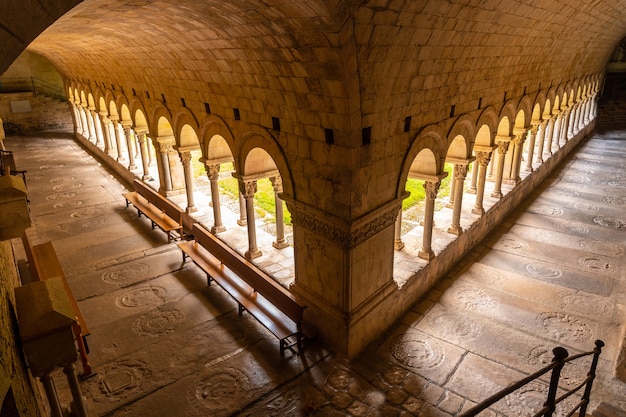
0;93;74;134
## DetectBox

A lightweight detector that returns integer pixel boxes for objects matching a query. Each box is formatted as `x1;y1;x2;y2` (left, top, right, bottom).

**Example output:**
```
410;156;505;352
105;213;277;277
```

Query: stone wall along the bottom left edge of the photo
0;241;47;417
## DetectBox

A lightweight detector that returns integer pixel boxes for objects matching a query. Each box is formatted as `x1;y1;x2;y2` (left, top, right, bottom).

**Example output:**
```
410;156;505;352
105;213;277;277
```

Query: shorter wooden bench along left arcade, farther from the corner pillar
122;179;184;243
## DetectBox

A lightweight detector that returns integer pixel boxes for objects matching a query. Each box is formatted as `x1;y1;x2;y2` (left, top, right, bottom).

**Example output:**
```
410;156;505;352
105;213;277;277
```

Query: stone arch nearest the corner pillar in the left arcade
233;131;296;199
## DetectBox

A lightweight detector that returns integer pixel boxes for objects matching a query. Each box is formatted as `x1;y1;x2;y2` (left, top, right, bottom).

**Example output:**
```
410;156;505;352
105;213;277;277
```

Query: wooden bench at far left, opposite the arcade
22;233;92;378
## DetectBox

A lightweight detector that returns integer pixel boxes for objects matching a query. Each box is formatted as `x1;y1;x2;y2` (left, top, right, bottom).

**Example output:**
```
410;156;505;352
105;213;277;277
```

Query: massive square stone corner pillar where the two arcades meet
283;195;402;357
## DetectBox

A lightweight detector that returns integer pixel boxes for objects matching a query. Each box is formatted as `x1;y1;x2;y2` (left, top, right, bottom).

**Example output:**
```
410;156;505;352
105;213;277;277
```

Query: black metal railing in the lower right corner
460;340;604;417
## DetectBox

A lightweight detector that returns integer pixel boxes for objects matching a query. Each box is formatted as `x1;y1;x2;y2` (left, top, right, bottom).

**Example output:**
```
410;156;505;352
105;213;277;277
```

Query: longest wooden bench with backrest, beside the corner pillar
178;223;306;356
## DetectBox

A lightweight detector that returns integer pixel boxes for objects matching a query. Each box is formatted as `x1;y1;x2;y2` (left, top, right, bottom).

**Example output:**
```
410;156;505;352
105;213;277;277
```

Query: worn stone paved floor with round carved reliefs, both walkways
5;128;626;417
